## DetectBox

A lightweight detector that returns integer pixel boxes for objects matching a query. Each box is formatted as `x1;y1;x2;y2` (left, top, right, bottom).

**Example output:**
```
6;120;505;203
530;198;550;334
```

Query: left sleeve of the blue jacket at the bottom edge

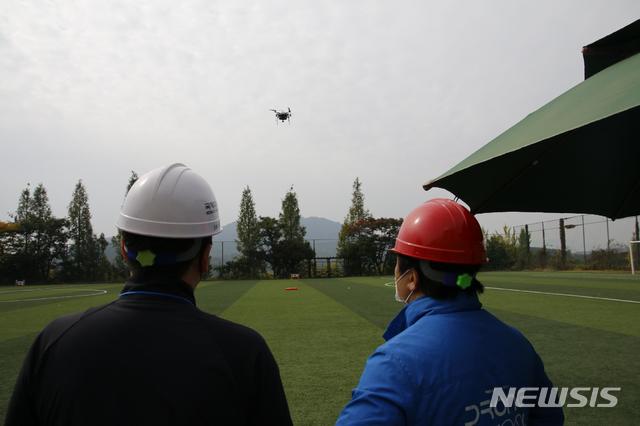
336;350;415;426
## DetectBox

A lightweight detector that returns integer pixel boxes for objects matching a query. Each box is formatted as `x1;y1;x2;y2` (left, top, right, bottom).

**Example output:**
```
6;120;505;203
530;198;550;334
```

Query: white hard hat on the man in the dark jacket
116;163;222;238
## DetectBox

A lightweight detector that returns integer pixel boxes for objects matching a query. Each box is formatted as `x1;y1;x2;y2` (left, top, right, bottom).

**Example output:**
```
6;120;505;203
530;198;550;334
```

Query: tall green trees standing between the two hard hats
228;178;402;278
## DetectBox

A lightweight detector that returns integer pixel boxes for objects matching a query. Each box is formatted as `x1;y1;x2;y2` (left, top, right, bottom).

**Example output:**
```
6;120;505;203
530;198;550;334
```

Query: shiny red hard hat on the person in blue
391;198;487;265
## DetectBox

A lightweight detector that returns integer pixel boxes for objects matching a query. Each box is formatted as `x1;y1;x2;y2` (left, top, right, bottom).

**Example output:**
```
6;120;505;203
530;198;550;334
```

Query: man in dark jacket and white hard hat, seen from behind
6;164;291;426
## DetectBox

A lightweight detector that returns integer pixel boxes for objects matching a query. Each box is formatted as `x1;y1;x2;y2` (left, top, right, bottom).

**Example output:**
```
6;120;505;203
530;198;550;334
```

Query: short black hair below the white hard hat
120;231;213;282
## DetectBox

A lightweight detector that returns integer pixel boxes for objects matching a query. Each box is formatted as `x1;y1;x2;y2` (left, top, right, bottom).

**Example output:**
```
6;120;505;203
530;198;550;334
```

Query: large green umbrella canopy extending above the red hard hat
424;21;640;219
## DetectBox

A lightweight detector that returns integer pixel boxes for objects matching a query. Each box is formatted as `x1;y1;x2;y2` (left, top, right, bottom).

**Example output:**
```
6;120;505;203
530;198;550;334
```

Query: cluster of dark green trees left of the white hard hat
0;172;138;284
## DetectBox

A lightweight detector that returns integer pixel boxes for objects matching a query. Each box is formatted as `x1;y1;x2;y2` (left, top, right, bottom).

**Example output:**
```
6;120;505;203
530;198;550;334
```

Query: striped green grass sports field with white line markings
0;272;640;425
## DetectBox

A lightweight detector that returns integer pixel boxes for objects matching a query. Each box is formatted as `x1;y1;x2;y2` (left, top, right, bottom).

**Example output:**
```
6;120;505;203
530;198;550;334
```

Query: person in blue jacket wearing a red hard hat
337;199;564;426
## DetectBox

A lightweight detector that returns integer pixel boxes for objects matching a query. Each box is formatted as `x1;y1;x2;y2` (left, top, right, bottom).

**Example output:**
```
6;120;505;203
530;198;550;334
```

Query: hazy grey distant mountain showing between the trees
106;217;342;266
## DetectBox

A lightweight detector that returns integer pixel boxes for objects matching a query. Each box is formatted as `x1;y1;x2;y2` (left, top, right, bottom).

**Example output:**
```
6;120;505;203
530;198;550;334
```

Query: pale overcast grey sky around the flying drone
0;0;640;235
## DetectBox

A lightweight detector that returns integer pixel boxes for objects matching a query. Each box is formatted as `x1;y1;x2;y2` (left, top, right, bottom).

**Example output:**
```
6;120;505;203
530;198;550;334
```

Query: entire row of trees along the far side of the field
7;171;616;284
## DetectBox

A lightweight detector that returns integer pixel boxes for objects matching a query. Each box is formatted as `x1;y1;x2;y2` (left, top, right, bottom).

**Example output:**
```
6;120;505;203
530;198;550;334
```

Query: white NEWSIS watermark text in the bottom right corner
489;387;622;408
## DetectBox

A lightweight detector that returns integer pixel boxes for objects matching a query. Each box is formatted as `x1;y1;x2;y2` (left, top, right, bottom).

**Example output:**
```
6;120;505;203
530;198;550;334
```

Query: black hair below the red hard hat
397;254;484;299
